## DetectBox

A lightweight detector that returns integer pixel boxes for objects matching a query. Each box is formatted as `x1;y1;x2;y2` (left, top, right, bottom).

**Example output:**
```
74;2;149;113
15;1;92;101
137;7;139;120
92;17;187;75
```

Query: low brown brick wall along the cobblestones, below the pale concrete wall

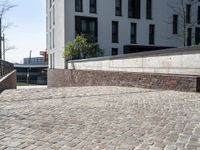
48;69;200;92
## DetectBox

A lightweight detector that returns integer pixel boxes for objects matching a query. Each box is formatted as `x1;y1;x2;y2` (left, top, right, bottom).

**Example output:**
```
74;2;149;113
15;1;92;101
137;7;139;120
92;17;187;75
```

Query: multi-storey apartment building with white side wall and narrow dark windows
46;0;200;69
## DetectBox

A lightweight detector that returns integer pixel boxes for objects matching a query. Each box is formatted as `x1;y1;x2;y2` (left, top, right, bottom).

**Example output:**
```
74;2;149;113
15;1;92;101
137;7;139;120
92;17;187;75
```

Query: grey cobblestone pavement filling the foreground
0;87;200;150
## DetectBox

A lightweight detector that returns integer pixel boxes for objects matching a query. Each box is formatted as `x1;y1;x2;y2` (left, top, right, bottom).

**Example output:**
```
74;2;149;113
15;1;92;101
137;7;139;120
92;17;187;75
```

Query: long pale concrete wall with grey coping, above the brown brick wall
67;46;200;76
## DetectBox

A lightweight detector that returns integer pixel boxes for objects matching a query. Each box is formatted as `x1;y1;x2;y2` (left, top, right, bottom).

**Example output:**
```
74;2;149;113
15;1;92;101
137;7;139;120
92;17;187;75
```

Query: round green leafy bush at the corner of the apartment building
63;34;103;59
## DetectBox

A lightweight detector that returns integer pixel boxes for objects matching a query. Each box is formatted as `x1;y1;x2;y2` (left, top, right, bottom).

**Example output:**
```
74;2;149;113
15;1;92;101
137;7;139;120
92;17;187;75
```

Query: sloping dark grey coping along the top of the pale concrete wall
68;45;200;63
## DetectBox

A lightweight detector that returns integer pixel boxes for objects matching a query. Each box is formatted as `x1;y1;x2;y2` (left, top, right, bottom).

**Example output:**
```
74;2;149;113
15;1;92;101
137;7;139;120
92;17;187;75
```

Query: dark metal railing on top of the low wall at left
0;59;14;78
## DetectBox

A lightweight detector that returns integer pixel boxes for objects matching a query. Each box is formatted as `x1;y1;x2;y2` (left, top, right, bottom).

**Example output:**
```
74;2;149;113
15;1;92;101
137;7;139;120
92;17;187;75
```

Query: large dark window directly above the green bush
75;16;98;42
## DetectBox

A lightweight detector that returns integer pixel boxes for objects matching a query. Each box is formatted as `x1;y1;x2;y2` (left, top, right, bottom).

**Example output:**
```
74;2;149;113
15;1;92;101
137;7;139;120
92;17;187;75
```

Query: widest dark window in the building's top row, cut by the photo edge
128;0;140;19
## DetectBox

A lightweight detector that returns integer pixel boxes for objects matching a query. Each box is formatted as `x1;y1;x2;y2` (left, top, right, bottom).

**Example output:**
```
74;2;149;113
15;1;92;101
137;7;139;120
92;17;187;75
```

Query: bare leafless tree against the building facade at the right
168;0;199;46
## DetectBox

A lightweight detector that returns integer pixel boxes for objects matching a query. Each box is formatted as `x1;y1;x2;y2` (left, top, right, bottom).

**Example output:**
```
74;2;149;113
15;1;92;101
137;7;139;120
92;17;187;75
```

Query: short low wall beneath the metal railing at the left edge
0;70;17;93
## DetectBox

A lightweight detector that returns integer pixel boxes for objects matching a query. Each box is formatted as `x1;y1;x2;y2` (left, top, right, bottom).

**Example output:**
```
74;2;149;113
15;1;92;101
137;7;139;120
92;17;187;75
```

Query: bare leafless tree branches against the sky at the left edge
0;0;15;59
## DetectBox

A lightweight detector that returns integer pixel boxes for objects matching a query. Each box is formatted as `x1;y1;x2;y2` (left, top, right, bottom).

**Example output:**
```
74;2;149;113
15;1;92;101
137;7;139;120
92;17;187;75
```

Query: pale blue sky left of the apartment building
3;0;46;63
